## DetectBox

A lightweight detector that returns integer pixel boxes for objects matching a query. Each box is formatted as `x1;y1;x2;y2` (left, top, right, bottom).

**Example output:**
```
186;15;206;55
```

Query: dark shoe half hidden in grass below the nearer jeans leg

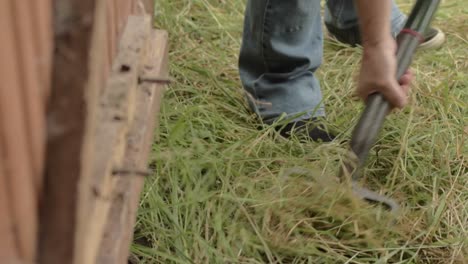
276;118;336;142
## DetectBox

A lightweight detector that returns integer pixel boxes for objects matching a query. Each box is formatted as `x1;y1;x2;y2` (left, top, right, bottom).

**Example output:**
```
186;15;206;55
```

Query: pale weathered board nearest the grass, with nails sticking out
97;27;168;264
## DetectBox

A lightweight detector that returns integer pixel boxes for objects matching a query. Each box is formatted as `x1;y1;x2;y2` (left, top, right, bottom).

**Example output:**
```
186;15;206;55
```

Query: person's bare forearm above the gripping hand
355;0;392;48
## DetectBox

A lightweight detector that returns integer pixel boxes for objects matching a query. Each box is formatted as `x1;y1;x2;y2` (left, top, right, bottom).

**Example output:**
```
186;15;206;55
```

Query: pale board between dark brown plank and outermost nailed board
74;16;150;264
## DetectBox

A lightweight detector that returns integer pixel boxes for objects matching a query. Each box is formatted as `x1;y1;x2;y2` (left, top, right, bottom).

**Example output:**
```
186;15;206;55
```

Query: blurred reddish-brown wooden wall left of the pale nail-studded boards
0;0;161;264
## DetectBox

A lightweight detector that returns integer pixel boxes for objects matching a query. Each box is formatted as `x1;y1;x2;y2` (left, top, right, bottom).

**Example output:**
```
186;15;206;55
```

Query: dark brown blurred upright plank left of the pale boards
39;0;95;264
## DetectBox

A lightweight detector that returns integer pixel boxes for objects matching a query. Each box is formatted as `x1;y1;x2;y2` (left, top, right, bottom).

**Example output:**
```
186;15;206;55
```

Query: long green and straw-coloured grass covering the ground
132;0;468;263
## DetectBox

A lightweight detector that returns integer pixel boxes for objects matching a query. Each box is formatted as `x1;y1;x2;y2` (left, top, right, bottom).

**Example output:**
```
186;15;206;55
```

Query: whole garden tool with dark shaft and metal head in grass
340;0;440;213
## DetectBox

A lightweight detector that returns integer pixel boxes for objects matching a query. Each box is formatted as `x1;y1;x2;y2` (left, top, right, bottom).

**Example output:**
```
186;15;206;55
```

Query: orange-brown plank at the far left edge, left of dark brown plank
0;1;41;261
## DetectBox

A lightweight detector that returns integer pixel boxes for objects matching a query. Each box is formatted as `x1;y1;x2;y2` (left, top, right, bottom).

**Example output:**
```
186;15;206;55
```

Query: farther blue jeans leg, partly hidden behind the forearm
324;0;406;45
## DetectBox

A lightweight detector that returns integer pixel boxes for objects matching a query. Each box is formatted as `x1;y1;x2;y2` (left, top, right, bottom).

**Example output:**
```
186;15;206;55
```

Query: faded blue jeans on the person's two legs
239;0;406;123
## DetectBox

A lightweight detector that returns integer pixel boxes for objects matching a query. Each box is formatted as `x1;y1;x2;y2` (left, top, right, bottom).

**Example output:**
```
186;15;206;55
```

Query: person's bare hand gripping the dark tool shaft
357;37;413;108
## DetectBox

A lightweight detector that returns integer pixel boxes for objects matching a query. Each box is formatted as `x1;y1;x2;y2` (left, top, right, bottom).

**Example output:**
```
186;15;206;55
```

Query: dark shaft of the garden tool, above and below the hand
351;0;440;180
